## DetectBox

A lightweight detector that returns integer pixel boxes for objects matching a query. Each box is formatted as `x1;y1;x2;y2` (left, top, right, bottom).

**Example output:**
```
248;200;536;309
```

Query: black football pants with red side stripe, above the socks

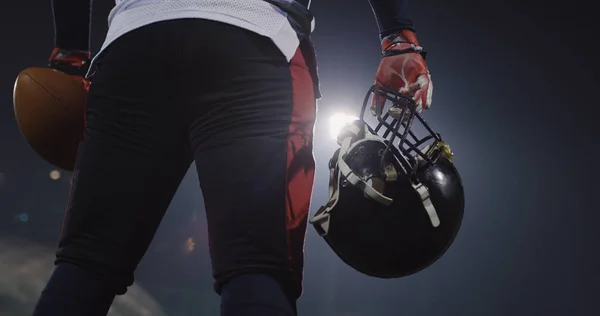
35;19;316;314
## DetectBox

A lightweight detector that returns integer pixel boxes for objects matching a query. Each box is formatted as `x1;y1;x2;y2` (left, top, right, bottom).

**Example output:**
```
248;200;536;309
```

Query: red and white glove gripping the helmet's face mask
371;30;433;116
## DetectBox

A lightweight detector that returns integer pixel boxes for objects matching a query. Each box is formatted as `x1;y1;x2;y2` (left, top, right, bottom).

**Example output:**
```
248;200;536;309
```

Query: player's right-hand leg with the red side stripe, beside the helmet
185;21;316;316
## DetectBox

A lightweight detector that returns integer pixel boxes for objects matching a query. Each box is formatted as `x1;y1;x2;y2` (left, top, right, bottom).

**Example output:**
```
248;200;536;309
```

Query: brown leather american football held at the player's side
13;67;87;171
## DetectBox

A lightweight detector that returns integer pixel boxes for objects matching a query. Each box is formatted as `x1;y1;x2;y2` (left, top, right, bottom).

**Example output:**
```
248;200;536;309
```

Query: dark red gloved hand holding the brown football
48;47;91;90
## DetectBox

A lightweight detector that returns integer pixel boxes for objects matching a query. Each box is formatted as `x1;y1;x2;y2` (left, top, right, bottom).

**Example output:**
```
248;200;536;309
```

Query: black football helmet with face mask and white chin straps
310;85;464;278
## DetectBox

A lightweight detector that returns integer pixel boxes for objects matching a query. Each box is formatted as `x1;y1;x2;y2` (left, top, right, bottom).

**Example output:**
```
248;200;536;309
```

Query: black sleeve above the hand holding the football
52;0;92;51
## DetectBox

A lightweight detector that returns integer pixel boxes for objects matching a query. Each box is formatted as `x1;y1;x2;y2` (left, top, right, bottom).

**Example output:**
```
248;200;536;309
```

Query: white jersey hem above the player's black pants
90;0;299;68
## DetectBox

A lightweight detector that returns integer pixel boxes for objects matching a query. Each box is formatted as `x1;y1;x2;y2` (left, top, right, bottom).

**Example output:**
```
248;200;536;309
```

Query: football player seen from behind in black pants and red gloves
34;0;432;316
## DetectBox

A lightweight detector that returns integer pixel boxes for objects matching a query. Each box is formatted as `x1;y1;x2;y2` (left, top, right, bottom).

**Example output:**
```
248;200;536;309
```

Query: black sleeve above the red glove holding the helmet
369;0;415;39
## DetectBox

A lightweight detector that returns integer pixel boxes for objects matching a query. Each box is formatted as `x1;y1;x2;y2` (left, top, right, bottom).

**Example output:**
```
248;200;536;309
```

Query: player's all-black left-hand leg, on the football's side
34;21;192;316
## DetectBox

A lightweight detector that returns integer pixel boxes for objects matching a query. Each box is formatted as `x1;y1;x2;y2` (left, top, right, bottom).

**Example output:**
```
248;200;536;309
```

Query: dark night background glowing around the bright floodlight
0;0;600;316
